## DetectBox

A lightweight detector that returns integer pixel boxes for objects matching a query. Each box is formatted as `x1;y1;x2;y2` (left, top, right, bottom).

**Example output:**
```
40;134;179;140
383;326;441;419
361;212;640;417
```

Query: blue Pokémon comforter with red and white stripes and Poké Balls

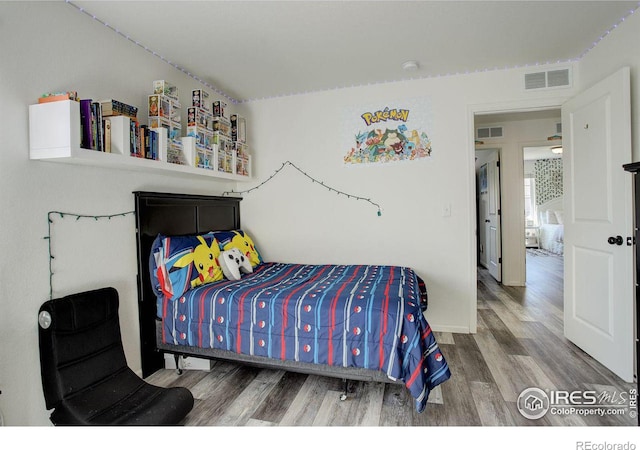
157;263;450;412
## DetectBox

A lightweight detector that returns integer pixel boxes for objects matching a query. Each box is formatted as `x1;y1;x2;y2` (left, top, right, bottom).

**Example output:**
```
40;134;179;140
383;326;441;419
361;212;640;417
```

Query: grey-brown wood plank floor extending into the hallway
147;252;637;427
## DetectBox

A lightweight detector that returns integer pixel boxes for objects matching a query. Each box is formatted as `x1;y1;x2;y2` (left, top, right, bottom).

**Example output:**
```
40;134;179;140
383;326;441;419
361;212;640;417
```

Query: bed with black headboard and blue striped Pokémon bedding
134;192;451;412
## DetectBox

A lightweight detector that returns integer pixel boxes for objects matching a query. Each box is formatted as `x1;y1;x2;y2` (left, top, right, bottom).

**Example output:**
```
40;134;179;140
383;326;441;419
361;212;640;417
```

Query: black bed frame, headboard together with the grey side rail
134;191;402;384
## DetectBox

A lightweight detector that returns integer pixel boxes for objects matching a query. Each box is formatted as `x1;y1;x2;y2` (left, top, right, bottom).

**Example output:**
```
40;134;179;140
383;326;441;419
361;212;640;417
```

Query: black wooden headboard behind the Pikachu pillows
133;191;242;377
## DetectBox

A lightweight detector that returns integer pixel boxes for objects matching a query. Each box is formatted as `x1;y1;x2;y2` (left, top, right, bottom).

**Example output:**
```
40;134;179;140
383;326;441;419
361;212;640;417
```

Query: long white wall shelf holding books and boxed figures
29;100;251;181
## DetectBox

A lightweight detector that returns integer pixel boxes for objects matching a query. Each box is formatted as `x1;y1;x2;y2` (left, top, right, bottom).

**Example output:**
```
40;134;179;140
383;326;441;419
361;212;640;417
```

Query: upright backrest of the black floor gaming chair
38;287;127;409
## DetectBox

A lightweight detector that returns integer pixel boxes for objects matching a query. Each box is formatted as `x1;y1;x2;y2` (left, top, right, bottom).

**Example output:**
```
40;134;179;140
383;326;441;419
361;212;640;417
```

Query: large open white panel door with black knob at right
562;68;634;382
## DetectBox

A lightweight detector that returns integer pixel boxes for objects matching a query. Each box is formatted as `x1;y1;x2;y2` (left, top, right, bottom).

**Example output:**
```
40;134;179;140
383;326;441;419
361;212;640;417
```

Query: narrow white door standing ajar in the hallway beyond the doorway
485;152;502;282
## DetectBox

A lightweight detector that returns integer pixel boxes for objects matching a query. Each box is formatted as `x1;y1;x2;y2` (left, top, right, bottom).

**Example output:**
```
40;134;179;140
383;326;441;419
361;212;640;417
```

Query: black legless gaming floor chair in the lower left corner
38;287;193;425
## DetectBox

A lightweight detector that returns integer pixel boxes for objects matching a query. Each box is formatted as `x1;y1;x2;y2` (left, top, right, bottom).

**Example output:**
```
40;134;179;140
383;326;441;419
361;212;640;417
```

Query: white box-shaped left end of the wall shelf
29;100;81;159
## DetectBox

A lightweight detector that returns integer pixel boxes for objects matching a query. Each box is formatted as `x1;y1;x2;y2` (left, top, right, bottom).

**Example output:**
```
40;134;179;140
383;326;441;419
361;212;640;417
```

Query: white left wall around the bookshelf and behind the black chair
0;2;245;425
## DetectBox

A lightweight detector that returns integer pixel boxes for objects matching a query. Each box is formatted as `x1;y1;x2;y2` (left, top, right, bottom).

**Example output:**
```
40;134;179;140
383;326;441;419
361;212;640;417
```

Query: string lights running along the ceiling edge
65;0;640;104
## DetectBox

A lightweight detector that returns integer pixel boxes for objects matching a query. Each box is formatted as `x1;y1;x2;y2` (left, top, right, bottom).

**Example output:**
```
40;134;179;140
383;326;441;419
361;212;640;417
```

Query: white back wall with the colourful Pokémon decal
243;69;572;338
